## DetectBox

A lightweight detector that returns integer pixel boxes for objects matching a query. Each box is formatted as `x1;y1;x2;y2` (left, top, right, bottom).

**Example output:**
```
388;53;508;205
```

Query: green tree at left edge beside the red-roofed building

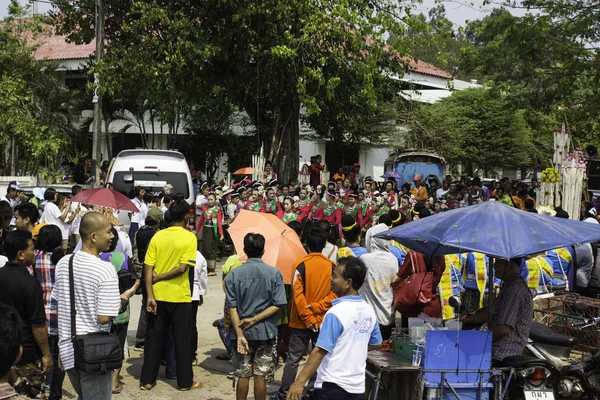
0;2;75;175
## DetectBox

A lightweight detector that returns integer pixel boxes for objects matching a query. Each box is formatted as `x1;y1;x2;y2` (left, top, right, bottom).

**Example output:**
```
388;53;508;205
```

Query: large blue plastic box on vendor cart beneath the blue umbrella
423;331;492;384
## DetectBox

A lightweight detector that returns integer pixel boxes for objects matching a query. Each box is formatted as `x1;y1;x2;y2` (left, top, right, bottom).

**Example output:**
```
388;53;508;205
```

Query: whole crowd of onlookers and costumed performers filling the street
0;159;600;400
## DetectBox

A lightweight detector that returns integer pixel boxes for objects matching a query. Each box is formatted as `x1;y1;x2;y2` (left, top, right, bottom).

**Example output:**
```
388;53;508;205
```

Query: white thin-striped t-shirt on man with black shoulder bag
52;251;121;370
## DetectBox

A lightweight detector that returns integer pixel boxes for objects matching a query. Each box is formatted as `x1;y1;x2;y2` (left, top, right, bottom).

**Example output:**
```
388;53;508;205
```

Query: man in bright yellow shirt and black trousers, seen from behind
140;200;202;390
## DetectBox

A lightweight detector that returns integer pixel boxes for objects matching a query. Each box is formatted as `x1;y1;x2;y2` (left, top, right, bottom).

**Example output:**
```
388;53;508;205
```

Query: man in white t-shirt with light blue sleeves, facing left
287;257;382;400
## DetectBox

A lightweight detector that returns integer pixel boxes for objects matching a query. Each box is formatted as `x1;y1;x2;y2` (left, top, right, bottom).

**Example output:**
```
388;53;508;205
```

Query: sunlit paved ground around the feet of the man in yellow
63;264;290;400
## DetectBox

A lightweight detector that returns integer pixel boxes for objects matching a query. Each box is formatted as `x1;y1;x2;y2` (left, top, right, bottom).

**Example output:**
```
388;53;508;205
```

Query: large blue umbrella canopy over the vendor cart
376;201;600;259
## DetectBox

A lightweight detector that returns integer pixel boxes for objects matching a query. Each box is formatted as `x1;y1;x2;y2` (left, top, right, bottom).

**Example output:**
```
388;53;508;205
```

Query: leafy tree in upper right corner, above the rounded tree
461;8;600;170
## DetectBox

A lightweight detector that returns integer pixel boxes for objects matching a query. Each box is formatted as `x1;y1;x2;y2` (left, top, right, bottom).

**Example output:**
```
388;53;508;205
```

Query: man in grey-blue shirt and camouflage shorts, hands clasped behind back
225;233;287;400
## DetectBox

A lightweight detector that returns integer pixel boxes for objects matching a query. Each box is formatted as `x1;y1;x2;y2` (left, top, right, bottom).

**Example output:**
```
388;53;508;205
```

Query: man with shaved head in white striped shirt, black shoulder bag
52;212;133;399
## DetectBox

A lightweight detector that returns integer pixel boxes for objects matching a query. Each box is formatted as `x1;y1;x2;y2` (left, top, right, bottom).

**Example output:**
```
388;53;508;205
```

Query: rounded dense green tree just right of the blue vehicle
406;89;532;176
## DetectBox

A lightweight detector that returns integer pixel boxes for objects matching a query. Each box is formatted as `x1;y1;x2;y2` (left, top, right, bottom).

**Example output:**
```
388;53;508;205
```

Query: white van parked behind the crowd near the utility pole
107;149;195;205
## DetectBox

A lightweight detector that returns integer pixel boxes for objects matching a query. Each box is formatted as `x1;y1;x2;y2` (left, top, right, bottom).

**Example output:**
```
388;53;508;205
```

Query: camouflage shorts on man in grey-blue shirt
231;339;277;378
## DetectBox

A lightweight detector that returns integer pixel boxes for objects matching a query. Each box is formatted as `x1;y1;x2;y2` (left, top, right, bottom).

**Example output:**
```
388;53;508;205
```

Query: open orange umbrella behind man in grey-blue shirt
229;210;306;284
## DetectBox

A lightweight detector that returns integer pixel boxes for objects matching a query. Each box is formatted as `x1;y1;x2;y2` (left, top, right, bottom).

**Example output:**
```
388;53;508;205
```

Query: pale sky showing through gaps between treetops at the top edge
0;0;524;27
